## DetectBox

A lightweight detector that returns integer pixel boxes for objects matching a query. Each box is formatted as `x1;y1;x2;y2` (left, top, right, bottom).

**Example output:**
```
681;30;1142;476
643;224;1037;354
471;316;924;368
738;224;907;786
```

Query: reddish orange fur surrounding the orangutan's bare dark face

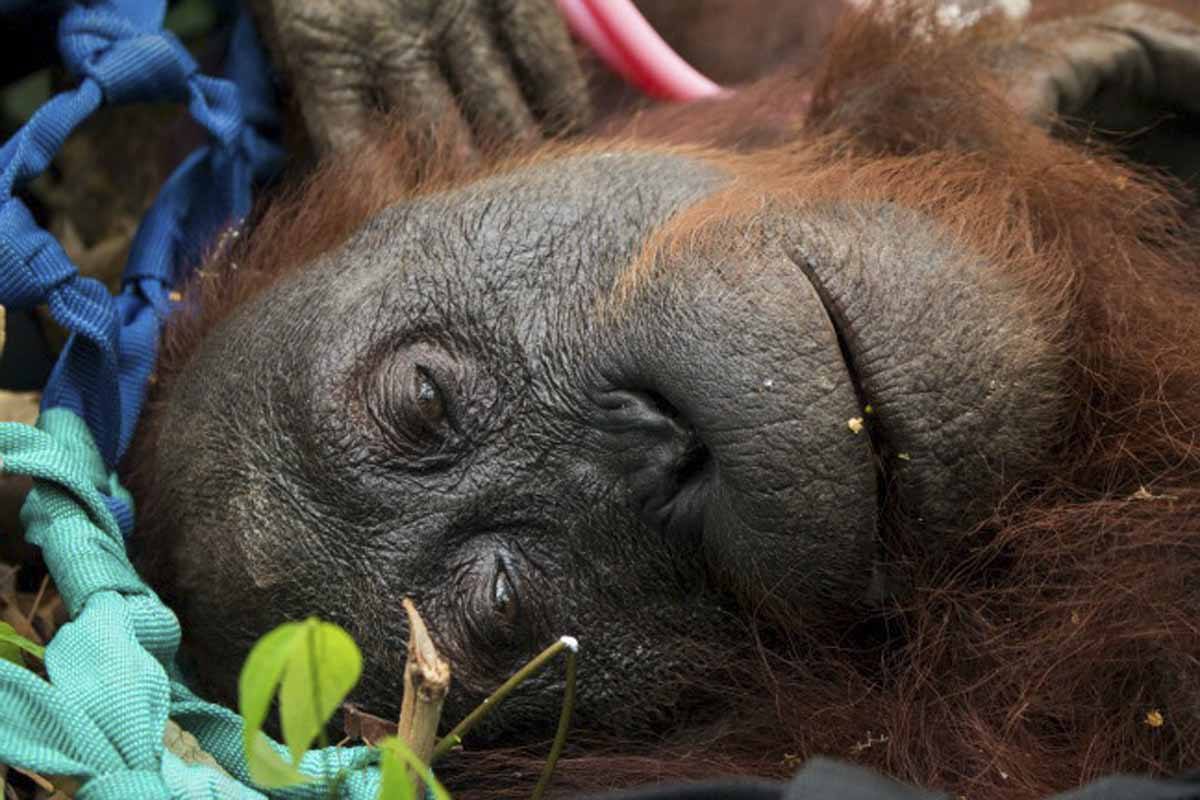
124;3;1200;800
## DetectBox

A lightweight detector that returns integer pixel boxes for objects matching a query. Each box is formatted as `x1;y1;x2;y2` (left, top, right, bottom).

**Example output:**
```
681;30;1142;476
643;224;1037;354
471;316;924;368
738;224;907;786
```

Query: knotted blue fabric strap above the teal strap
0;0;282;472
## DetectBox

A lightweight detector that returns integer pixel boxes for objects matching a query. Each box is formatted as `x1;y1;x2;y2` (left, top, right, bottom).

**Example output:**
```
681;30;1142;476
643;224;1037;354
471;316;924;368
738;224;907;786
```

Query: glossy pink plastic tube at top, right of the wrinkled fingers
558;0;725;101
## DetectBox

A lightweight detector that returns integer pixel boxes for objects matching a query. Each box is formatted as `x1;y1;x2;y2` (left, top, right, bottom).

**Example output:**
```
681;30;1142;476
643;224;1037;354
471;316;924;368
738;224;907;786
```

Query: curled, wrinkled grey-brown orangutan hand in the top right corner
995;2;1200;184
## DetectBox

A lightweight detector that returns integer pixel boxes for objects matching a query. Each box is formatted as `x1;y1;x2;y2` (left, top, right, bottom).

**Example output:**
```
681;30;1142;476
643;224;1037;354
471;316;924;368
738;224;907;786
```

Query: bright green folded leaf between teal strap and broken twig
238;618;362;788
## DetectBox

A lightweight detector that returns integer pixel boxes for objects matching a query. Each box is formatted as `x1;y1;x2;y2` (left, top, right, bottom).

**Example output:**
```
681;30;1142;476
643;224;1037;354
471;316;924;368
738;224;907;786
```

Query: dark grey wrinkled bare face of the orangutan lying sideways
145;151;1058;736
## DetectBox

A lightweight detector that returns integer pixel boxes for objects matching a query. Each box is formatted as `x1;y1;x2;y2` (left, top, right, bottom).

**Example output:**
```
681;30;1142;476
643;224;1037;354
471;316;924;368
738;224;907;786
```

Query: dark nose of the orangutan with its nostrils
599;390;709;535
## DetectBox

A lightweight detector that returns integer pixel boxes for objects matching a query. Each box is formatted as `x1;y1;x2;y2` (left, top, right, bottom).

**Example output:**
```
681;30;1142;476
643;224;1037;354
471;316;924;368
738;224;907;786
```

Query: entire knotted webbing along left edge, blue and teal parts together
0;0;378;800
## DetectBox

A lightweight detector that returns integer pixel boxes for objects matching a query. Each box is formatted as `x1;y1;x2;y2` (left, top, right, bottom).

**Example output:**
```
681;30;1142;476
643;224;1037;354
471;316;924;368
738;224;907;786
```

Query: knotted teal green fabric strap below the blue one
0;409;379;800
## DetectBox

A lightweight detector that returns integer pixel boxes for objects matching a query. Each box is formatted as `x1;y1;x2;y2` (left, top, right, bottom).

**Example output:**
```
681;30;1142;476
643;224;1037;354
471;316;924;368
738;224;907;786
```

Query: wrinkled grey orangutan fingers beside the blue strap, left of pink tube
250;0;588;151
